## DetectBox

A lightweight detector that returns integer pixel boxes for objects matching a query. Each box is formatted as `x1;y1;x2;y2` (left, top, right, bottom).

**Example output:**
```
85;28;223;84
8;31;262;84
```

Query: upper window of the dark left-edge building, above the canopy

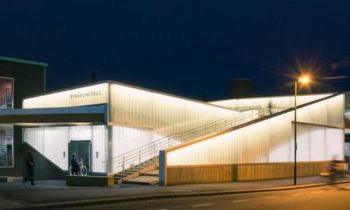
0;77;13;109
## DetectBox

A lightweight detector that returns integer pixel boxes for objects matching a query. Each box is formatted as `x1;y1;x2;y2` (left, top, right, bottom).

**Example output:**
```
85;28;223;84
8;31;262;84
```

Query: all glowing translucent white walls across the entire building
18;82;344;175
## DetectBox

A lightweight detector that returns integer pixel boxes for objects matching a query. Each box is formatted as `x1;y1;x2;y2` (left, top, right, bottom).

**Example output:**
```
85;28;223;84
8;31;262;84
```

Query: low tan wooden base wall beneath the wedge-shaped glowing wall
163;161;329;185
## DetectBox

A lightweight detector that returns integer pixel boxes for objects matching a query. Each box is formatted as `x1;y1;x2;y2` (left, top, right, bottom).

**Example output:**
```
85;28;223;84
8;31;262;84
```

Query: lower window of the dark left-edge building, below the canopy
0;125;13;167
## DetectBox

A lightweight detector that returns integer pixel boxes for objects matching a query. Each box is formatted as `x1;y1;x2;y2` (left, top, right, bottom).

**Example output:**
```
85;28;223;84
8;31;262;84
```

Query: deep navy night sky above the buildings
0;0;350;100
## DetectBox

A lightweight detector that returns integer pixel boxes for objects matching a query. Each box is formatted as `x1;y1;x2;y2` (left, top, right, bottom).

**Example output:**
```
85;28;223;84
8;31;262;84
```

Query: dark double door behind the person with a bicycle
68;140;91;172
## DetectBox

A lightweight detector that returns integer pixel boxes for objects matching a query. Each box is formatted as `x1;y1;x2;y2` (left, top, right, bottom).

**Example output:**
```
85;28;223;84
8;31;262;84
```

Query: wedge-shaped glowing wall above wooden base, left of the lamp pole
167;111;291;165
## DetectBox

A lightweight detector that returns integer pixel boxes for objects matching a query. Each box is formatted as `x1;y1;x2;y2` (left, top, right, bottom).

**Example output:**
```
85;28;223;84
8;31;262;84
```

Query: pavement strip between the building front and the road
0;175;350;209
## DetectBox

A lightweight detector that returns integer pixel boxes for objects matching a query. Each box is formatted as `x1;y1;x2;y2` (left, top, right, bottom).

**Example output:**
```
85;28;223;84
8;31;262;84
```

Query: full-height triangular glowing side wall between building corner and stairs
110;83;238;172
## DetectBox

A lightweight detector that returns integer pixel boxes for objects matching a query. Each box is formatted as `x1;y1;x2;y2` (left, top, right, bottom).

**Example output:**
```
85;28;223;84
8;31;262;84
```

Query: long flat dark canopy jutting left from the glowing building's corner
0;104;107;125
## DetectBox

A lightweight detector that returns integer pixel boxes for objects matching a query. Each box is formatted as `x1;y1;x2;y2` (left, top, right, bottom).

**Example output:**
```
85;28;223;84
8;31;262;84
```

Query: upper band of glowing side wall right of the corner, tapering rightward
111;84;237;135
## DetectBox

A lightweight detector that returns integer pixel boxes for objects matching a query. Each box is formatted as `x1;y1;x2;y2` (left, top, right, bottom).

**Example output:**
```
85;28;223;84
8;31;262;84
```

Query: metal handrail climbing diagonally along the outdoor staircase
105;107;286;171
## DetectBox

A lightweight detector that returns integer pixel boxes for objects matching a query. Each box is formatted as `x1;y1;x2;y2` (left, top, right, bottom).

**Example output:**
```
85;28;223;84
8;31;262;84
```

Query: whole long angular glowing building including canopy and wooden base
0;61;345;185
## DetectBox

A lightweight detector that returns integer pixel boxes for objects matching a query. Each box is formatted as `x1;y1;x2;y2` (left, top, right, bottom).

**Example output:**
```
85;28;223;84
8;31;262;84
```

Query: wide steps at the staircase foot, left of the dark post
114;157;159;184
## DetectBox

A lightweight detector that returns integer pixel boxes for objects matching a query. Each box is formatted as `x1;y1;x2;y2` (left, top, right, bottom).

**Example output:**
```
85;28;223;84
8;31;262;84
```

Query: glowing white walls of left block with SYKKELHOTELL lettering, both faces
23;82;238;172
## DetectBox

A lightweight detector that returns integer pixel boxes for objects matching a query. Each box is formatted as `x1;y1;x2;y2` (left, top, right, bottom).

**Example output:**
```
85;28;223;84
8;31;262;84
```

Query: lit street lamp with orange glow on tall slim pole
294;76;311;185
